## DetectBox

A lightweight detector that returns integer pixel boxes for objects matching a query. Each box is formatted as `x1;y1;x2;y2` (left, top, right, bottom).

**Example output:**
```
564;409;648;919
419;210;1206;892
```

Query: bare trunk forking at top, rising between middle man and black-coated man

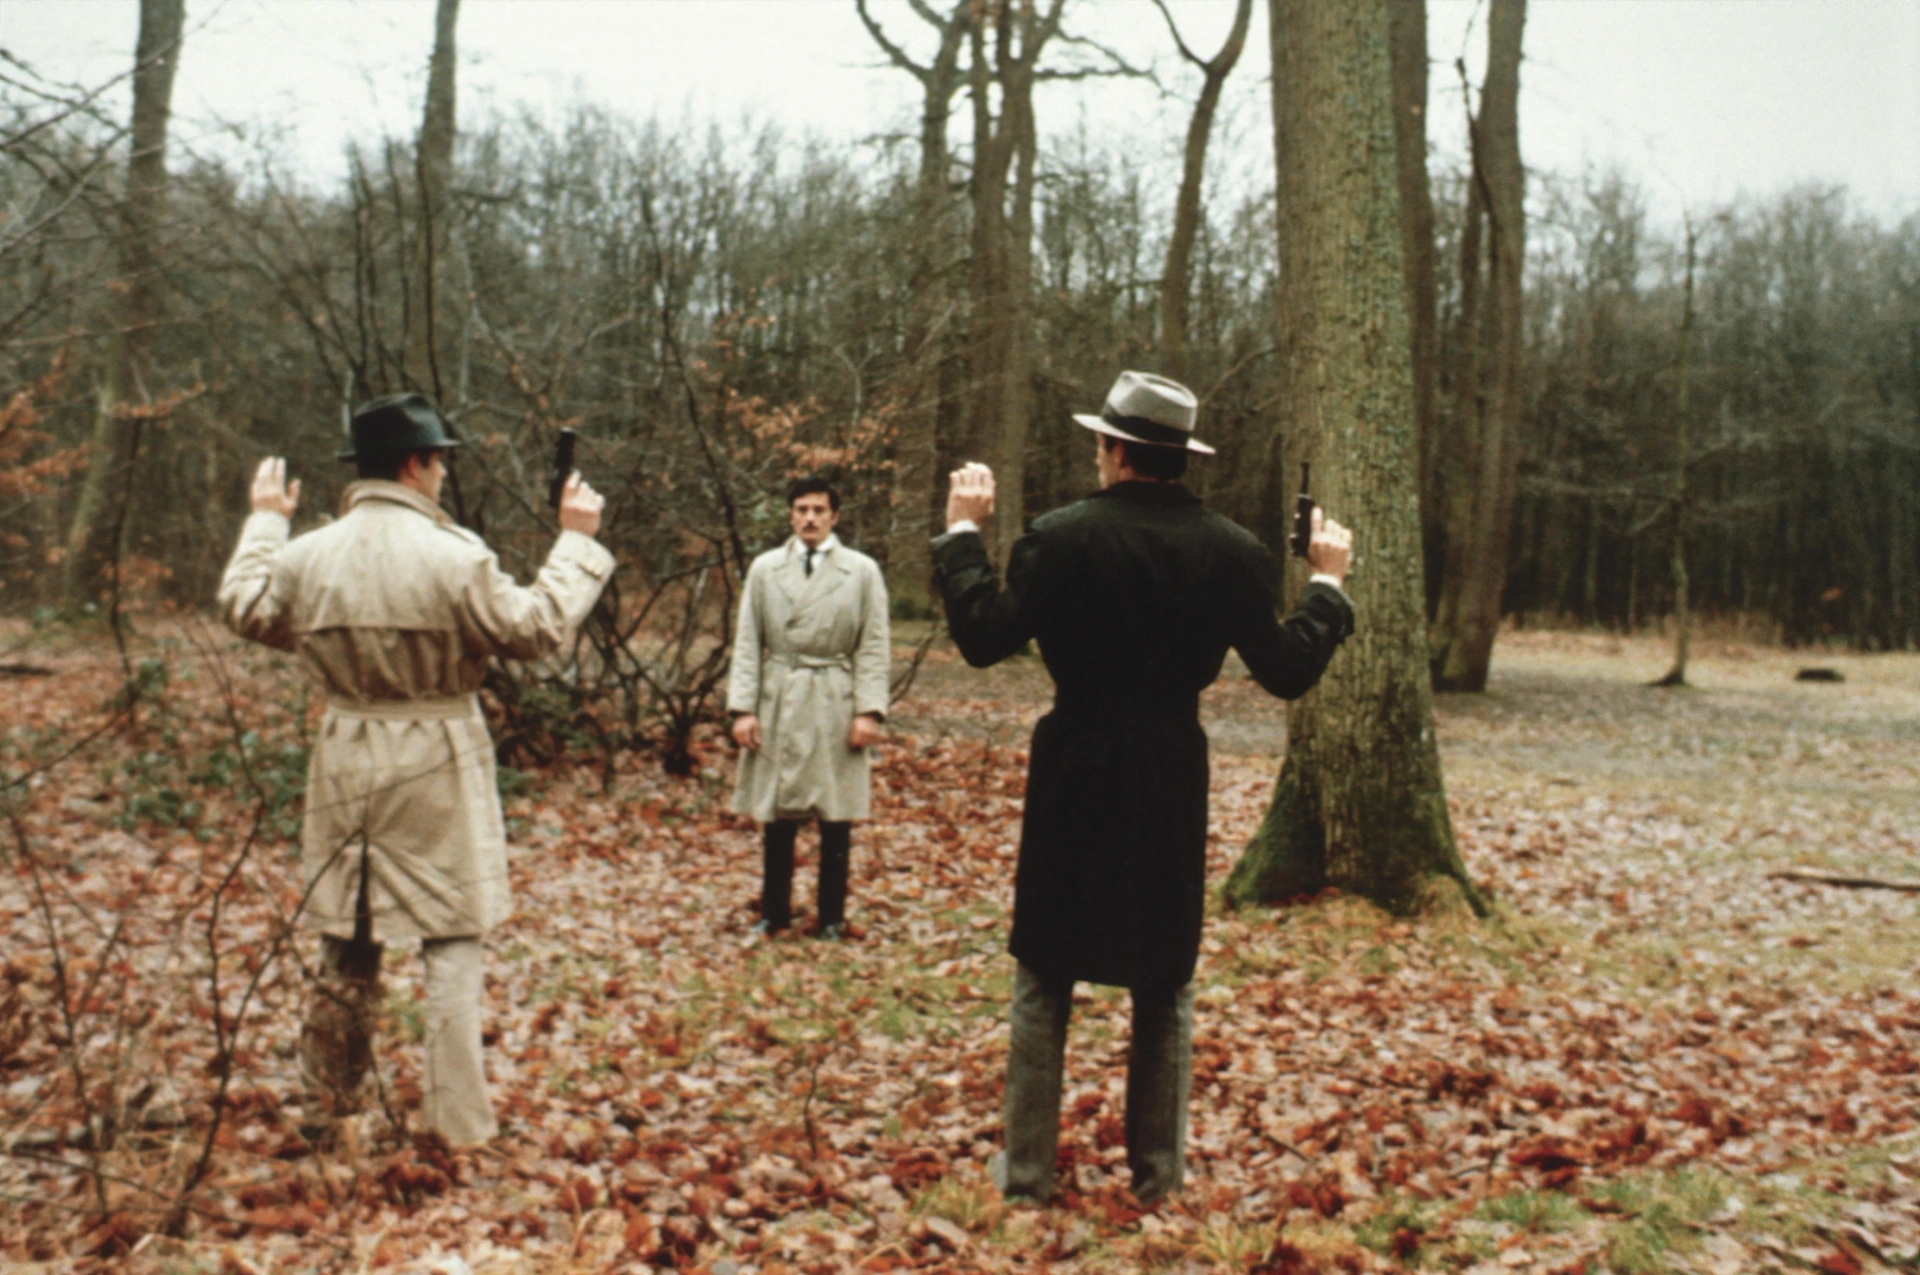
856;0;972;607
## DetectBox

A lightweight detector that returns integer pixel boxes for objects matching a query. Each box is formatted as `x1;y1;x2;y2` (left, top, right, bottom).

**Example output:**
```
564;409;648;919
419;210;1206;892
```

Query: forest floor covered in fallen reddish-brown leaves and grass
0;624;1920;1275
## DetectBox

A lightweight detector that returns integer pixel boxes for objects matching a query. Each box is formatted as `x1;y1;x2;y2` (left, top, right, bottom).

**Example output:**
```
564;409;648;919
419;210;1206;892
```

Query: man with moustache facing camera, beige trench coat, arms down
728;478;891;939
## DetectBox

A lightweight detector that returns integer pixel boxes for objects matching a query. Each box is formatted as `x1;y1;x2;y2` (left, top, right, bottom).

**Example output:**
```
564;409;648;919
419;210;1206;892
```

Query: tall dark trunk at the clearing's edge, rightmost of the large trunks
1428;0;1526;691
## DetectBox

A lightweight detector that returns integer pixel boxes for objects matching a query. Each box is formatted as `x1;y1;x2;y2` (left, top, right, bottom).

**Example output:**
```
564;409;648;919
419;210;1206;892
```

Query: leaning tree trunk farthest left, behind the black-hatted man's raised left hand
60;0;186;609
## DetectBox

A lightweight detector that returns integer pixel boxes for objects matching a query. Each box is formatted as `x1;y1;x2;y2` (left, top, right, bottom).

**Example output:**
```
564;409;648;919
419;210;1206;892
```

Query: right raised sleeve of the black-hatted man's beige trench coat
457;532;612;659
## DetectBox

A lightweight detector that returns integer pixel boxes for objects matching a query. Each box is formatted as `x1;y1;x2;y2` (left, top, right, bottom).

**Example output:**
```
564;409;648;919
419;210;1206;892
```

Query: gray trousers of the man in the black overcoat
1000;966;1194;1204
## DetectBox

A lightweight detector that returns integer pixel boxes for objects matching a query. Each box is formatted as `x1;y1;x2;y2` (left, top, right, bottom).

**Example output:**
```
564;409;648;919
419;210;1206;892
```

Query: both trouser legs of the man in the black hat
300;935;499;1146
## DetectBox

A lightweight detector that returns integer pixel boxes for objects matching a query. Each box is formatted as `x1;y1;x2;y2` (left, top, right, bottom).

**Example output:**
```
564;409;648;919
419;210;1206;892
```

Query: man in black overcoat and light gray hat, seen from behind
933;373;1354;1202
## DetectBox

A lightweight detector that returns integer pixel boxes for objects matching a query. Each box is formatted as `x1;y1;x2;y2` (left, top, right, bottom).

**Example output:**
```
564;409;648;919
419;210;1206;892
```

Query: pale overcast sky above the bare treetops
15;0;1920;221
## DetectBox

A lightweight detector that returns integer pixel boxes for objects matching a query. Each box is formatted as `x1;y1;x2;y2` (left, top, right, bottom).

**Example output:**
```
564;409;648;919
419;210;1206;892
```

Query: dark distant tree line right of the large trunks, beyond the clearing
1507;173;1920;651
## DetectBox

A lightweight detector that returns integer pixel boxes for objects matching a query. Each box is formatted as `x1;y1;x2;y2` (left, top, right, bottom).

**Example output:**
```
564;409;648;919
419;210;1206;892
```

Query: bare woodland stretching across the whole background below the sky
0;0;1920;687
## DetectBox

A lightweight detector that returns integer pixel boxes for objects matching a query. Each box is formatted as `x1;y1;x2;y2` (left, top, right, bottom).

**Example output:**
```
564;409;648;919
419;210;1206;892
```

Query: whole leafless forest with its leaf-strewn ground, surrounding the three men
0;0;1920;1273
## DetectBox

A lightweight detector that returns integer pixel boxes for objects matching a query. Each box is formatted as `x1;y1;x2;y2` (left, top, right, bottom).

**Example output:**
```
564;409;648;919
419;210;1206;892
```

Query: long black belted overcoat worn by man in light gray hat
933;482;1354;989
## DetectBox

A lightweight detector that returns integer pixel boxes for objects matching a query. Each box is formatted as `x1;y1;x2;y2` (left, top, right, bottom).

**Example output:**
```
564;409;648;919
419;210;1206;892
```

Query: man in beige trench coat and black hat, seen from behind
219;394;612;1146
